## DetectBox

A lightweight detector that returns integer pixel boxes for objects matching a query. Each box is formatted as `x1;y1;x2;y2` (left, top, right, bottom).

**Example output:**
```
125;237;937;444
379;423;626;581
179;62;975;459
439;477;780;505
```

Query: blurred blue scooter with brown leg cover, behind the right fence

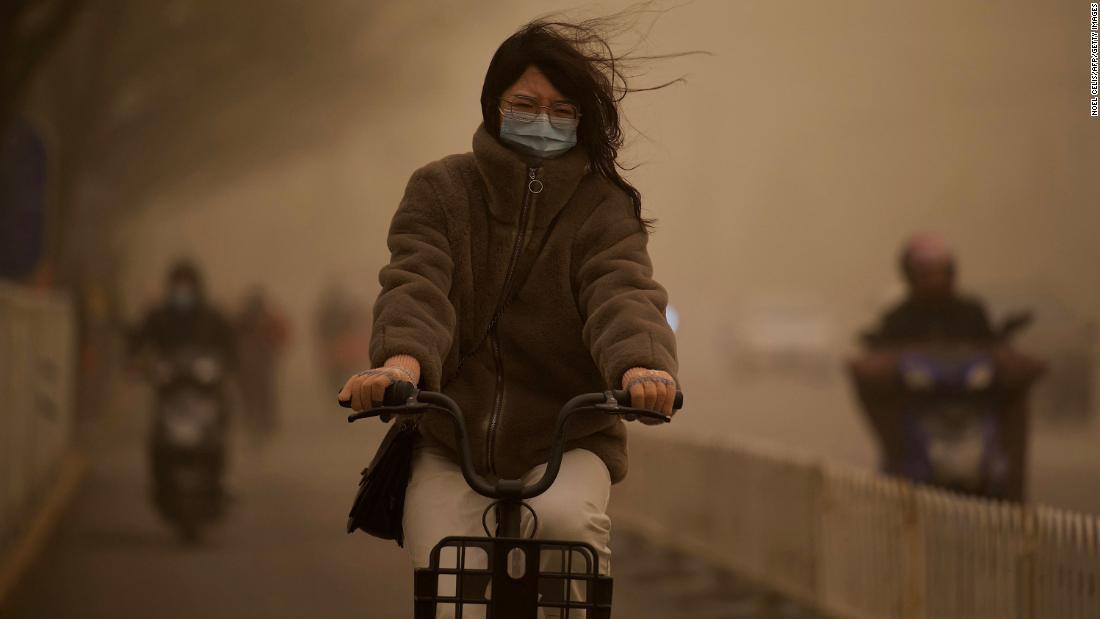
851;314;1043;500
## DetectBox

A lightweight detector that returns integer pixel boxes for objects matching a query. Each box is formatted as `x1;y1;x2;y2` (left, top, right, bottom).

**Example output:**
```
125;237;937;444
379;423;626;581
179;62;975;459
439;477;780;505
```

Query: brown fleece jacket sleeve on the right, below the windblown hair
573;195;678;389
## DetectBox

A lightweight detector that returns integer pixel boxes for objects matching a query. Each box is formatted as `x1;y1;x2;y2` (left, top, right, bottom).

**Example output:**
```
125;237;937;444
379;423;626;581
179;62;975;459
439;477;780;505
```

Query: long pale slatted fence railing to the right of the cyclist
612;432;1100;619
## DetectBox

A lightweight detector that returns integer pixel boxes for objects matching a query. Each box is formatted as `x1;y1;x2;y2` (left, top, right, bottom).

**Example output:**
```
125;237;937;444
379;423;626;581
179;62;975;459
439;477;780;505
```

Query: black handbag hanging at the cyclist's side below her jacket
348;421;420;546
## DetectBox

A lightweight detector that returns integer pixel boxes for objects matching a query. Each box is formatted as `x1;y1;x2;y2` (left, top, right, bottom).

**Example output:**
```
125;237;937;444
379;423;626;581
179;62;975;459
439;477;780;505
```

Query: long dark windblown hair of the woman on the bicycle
481;2;700;229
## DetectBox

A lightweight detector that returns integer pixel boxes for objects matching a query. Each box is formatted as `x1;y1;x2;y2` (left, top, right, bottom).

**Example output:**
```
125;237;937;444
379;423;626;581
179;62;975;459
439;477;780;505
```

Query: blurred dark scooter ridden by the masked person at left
150;349;227;543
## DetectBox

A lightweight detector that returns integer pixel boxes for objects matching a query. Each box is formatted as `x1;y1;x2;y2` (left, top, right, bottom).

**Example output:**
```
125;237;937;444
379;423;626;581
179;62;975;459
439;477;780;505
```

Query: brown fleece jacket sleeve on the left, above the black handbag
371;168;455;389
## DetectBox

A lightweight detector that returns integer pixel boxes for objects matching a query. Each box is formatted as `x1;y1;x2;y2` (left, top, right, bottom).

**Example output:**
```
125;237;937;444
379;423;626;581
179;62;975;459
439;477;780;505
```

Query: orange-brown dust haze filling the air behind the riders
8;0;1100;615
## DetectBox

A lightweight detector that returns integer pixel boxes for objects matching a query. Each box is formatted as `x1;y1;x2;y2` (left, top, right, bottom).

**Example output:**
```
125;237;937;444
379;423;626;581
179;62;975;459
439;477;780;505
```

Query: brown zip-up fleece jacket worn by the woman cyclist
371;126;677;482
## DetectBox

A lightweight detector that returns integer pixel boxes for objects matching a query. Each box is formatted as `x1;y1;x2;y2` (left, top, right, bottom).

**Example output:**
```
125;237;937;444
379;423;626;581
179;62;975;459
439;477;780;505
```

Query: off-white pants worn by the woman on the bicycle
402;446;612;618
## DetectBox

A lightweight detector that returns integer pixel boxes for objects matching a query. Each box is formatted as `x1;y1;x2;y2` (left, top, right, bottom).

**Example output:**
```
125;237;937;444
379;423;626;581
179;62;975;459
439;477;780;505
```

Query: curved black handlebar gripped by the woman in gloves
340;380;683;500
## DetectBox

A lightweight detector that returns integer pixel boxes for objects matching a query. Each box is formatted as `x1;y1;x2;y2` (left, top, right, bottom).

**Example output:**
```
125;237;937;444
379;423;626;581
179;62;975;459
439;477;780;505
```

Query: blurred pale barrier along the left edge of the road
0;283;74;556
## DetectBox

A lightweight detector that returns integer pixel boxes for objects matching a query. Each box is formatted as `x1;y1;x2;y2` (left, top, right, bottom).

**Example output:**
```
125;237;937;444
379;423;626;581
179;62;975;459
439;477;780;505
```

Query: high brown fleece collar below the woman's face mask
473;123;589;228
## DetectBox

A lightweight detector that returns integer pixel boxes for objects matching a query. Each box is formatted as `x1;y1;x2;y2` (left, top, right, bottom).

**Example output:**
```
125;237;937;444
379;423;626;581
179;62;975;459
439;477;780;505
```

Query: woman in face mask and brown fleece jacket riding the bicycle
339;13;677;584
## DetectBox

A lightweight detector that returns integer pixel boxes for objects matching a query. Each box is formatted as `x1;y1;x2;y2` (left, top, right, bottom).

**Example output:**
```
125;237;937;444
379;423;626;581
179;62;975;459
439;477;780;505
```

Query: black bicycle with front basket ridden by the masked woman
348;383;683;619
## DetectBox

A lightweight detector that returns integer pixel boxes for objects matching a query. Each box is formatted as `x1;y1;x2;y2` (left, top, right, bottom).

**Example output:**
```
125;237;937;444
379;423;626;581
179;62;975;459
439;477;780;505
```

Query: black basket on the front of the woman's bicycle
413;538;612;619
